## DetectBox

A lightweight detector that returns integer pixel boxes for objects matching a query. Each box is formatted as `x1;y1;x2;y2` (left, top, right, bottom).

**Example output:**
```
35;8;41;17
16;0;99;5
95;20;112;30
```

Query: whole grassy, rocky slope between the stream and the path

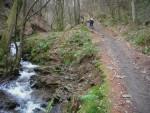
24;26;108;113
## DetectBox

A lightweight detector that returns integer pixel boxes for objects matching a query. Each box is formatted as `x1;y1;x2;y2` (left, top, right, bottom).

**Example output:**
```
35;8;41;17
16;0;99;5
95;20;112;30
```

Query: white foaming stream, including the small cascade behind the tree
0;44;44;113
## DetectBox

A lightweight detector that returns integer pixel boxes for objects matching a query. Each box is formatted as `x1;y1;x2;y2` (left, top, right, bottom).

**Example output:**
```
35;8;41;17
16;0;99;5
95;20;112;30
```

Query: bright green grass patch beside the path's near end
78;84;108;113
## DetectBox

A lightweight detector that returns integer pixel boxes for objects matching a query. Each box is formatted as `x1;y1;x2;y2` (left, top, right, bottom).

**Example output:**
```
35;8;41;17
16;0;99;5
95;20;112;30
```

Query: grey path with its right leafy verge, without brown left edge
95;23;150;113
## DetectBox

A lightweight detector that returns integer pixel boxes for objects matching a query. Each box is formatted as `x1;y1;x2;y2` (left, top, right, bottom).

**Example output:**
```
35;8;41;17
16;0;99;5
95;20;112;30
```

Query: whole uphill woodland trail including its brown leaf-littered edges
92;23;150;113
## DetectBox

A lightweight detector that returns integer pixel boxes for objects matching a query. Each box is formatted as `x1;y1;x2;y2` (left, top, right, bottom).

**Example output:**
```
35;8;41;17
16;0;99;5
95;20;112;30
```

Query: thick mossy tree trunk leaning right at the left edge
0;0;21;74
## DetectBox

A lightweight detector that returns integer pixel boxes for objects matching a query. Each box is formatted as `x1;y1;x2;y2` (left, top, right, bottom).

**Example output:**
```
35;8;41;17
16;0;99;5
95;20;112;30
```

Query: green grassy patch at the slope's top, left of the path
60;27;96;65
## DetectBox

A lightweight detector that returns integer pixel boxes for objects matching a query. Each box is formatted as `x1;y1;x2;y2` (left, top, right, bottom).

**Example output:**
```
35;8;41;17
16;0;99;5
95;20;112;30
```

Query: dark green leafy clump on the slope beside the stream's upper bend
24;32;61;64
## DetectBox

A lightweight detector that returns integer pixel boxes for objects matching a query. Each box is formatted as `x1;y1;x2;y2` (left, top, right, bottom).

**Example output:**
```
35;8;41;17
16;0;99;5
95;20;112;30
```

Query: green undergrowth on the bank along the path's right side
99;15;150;55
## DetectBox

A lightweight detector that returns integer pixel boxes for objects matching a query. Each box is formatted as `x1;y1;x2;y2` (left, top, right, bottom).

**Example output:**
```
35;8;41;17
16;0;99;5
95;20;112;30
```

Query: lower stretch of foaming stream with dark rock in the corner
0;61;44;113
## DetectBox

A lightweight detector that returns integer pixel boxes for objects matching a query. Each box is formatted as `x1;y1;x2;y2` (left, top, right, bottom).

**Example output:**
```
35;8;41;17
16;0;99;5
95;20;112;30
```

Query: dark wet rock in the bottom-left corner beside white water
0;91;19;111
